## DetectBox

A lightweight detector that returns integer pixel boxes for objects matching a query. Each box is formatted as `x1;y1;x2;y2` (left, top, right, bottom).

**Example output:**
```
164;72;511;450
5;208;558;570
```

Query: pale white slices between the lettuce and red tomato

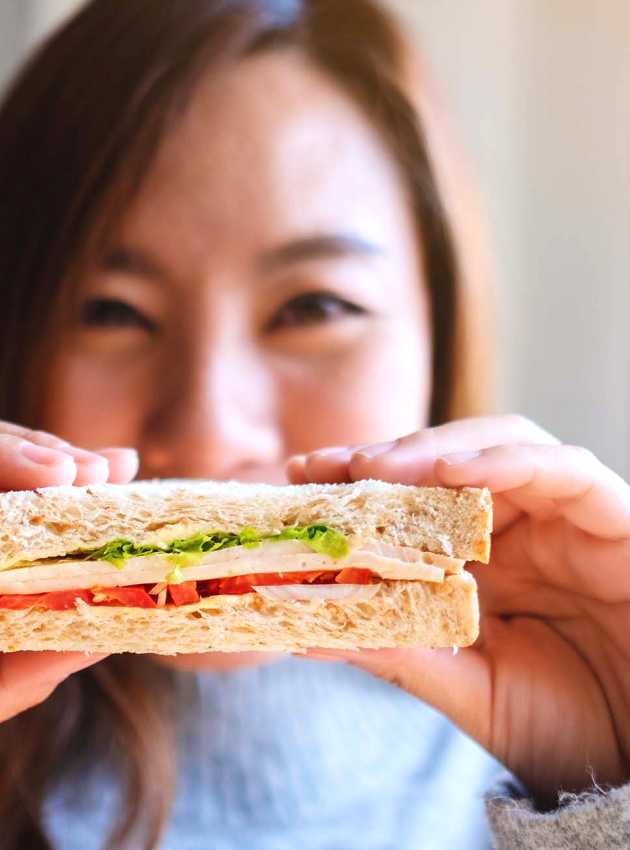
0;540;464;594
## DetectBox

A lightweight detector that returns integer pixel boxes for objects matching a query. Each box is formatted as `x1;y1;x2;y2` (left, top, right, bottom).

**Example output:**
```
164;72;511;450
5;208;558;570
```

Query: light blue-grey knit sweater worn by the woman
45;659;630;850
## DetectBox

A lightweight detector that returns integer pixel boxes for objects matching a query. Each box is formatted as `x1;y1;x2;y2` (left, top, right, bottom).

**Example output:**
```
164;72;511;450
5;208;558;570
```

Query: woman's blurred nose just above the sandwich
140;345;283;480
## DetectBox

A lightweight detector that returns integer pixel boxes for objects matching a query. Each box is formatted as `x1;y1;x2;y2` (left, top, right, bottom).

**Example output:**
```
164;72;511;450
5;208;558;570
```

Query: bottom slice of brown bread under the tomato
0;572;479;655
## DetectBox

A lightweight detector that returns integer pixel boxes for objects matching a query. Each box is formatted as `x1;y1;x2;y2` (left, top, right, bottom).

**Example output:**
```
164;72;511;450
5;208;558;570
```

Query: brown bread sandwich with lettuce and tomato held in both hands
0;481;492;655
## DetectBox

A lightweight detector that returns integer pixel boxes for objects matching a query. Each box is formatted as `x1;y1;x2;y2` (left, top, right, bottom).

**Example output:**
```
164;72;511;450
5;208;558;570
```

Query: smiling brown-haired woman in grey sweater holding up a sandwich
0;0;630;850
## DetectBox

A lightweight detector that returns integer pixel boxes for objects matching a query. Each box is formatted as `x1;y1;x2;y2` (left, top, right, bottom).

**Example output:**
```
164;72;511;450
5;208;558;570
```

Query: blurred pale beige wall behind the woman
0;0;630;477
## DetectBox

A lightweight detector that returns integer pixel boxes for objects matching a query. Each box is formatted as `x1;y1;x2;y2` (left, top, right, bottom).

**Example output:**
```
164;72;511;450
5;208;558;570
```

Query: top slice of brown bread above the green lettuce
0;480;492;569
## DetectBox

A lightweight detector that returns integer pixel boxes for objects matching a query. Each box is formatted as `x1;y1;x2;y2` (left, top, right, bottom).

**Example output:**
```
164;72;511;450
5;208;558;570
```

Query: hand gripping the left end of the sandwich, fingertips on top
0;422;138;722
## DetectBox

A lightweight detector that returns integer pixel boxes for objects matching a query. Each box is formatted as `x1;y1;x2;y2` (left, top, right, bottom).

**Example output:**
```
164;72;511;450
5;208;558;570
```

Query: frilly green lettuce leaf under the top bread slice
81;525;349;568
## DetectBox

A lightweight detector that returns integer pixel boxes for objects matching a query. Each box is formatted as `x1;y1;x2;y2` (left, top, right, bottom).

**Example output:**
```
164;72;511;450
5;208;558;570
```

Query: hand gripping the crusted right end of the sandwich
289;417;630;806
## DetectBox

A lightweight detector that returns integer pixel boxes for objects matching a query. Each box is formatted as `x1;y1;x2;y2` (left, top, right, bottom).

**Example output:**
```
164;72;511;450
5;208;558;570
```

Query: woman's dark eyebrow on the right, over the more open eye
259;233;385;272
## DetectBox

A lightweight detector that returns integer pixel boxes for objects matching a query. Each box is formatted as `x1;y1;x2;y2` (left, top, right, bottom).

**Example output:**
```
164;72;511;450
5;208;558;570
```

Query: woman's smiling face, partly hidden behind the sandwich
41;50;431;668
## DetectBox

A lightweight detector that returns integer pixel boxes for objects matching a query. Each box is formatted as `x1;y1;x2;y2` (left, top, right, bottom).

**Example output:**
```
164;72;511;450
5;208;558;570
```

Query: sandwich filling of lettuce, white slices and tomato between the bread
0;525;464;611
